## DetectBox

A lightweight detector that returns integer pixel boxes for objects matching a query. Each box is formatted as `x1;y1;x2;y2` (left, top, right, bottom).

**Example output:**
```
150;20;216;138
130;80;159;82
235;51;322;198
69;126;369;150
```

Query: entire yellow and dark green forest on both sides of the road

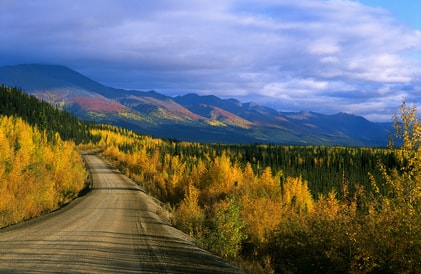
0;87;421;273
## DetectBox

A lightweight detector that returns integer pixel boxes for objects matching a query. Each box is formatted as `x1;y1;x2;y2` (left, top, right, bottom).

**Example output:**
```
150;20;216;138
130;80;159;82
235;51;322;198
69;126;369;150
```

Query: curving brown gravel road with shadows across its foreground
0;155;240;273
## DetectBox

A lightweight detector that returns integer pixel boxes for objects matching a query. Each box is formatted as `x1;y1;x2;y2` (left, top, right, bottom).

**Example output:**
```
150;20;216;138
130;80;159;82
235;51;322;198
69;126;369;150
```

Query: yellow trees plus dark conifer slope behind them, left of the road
0;86;91;227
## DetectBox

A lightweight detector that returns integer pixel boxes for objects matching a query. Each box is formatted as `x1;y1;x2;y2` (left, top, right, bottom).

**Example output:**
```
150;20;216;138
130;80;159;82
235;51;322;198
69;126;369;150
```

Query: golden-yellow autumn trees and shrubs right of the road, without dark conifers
95;107;421;273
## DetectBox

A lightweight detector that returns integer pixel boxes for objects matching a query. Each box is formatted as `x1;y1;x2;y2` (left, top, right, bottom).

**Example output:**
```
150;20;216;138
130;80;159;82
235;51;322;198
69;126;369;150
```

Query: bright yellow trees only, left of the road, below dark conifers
0;116;87;227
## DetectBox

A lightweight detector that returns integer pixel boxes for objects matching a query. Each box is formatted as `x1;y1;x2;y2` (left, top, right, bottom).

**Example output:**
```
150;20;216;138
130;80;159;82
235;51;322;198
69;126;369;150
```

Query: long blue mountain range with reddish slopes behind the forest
0;65;388;146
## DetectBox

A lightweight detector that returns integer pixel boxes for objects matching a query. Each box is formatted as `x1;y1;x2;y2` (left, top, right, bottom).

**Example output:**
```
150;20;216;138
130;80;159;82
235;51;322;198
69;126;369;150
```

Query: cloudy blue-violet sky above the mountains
0;0;421;121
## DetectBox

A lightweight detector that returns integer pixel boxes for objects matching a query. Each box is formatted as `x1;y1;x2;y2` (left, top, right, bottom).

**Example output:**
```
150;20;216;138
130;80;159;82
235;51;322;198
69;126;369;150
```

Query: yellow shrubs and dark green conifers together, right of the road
93;100;421;273
